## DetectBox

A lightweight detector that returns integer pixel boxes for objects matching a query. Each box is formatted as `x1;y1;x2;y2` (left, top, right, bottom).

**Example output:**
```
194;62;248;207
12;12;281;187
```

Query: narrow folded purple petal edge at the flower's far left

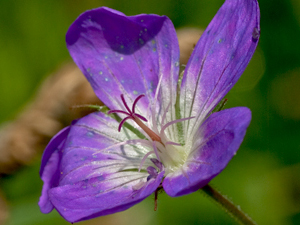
39;127;70;213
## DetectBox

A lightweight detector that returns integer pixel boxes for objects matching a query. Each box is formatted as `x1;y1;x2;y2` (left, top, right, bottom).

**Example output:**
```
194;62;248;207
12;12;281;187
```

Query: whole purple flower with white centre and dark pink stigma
39;0;260;222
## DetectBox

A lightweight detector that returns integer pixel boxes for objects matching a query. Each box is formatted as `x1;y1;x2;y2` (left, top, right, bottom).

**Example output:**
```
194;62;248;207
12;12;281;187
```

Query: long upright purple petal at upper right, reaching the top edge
180;0;260;138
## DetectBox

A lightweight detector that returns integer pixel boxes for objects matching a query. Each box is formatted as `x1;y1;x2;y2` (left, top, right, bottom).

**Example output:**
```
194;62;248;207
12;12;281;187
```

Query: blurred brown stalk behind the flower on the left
0;64;100;174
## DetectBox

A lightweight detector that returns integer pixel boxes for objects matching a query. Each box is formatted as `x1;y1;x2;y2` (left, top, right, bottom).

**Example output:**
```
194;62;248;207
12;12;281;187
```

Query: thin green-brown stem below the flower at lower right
199;184;256;225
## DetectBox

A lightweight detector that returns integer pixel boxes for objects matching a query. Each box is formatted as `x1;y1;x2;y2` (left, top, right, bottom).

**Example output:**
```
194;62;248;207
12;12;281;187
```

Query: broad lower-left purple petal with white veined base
40;112;164;222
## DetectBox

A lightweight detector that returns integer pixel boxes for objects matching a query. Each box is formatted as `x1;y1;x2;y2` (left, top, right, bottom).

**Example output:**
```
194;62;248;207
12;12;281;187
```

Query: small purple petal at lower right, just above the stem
163;107;251;197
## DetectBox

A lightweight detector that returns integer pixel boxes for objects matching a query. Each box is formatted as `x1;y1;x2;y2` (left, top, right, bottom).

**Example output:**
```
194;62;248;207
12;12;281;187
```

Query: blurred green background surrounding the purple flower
0;0;300;225
